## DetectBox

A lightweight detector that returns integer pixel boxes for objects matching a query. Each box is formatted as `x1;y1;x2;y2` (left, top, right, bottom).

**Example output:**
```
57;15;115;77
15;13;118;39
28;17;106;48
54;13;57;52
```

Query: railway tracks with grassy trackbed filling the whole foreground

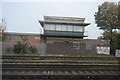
2;56;120;80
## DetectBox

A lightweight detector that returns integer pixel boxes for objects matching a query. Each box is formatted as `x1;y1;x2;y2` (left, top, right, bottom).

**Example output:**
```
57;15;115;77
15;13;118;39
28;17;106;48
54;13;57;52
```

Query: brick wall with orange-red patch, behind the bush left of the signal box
2;33;40;53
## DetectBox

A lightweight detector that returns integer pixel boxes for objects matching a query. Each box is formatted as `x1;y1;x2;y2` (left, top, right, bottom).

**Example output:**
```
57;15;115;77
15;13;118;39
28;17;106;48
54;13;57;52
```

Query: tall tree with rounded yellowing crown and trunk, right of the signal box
94;2;120;53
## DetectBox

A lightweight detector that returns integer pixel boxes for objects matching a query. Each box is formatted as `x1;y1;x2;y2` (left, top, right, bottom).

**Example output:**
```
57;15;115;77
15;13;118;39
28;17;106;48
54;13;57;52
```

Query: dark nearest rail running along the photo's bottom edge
3;75;119;80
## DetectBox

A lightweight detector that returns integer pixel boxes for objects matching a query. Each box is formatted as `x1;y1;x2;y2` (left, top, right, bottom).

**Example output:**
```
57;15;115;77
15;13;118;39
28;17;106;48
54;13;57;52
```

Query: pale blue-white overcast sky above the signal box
0;0;118;39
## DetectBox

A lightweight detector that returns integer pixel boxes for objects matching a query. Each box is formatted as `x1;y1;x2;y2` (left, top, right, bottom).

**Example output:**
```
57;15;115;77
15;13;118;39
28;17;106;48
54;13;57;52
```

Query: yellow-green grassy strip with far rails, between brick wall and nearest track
2;54;119;65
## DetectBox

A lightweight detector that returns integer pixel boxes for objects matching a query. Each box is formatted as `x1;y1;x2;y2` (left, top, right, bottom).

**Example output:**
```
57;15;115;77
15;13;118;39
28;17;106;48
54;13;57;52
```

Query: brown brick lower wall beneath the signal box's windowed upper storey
46;38;109;54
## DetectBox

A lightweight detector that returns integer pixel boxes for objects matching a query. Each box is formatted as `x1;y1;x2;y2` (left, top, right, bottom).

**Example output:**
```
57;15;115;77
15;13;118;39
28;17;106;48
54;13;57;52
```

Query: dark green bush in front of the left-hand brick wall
13;42;37;54
